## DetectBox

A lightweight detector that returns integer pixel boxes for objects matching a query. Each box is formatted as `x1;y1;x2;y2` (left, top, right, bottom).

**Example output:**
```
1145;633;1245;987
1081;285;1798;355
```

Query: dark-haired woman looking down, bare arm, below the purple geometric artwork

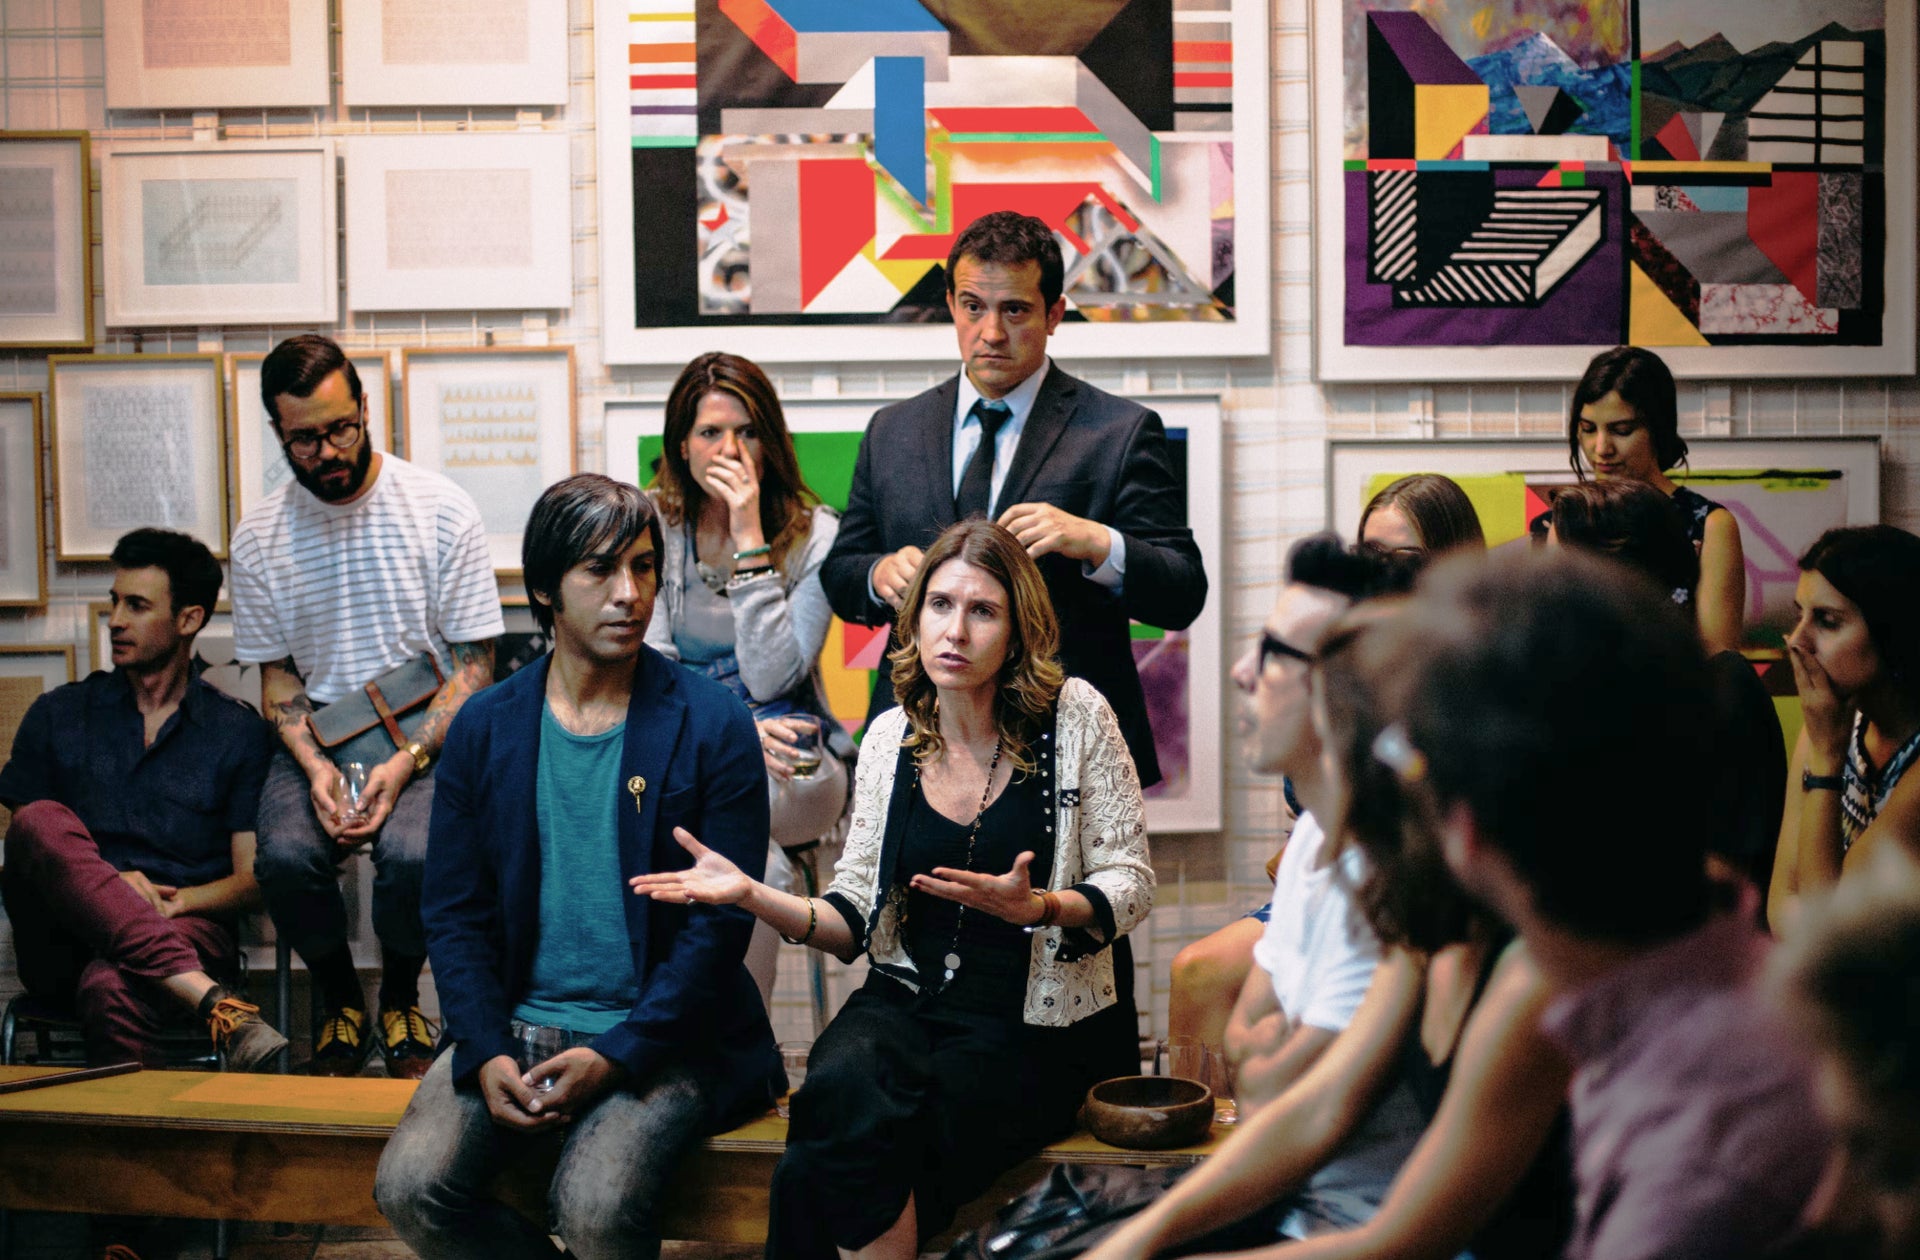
1567;346;1747;651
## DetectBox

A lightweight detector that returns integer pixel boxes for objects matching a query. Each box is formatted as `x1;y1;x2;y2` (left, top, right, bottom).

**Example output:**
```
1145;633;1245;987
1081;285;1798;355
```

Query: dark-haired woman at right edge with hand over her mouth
1768;524;1920;926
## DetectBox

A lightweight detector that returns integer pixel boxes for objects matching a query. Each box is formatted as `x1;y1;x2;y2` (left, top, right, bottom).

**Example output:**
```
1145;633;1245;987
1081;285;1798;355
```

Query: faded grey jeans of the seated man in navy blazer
372;1053;708;1260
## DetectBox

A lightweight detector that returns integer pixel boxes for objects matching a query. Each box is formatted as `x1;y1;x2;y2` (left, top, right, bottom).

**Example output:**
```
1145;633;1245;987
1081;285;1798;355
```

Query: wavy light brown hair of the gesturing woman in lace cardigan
887;519;1066;772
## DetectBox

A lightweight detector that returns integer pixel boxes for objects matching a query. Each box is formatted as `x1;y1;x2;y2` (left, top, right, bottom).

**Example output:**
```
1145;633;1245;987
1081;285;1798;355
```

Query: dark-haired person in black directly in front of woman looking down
1548;480;1788;891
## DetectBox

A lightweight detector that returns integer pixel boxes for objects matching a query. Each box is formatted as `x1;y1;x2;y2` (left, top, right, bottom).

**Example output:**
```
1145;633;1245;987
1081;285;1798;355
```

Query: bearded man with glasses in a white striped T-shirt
232;336;505;1078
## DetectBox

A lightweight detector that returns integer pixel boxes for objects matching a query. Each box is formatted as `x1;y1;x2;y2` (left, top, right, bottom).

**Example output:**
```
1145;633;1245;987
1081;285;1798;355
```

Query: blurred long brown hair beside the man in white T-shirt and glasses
1313;597;1494;953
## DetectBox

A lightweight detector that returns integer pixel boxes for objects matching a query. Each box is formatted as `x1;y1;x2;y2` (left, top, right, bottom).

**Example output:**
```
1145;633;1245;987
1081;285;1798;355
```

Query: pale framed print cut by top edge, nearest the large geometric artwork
340;0;566;108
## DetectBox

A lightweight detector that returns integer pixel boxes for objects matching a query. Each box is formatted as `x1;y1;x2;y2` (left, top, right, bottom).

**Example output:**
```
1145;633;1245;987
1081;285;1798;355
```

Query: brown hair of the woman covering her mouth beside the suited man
647;350;820;569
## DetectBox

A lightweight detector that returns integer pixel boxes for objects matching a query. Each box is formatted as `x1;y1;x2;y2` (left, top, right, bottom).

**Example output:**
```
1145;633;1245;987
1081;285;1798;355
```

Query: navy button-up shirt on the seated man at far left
0;670;273;887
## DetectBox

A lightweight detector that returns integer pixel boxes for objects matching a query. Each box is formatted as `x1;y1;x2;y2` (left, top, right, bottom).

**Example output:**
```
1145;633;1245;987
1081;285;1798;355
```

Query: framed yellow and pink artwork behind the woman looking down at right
1327;438;1880;647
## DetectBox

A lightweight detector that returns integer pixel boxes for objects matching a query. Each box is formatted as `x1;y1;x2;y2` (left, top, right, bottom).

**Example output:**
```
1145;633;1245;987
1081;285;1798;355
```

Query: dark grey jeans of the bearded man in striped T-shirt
253;749;434;958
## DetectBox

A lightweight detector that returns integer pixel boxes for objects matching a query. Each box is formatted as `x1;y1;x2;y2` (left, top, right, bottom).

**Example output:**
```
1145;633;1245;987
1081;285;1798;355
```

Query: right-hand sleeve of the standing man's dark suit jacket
1104;409;1206;630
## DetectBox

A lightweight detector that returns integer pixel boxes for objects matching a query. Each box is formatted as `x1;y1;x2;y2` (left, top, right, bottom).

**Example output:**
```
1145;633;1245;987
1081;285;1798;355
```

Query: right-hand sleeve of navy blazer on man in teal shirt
593;701;770;1081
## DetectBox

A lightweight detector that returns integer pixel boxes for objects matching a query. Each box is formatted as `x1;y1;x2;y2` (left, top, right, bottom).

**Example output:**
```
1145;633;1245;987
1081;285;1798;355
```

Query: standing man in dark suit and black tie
820;211;1206;784
